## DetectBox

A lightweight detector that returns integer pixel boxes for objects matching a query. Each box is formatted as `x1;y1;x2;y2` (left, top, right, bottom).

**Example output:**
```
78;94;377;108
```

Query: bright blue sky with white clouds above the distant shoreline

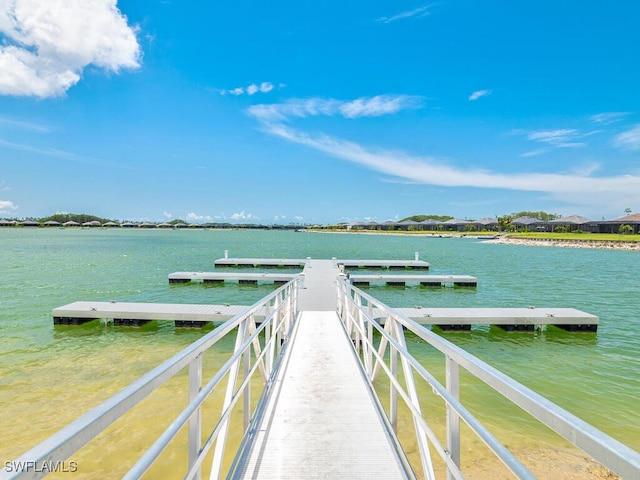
0;0;640;224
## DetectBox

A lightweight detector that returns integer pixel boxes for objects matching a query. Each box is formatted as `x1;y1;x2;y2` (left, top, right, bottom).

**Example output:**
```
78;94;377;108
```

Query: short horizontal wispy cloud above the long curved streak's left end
248;95;422;122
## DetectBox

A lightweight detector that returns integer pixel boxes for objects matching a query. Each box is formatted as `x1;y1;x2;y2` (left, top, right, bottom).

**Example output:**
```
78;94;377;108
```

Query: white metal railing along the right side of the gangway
338;280;640;479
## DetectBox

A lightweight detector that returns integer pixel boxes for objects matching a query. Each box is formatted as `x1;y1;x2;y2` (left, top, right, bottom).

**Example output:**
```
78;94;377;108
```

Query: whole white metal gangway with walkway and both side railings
6;260;640;479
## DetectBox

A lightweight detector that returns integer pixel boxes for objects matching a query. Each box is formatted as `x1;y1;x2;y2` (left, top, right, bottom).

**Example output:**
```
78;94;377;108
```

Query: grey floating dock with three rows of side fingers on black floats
52;254;599;332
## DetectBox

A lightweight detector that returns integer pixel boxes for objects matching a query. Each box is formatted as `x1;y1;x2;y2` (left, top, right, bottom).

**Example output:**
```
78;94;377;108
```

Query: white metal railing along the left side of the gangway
8;278;298;480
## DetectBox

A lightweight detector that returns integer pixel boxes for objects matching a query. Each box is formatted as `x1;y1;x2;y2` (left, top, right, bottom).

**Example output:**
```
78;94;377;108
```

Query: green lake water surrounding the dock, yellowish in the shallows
0;228;640;478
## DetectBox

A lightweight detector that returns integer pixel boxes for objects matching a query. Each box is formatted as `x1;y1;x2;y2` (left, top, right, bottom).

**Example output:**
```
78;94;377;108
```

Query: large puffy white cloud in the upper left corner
0;0;141;97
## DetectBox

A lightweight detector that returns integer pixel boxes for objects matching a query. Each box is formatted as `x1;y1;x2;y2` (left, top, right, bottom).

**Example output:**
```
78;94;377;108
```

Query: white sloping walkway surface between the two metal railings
238;311;413;479
